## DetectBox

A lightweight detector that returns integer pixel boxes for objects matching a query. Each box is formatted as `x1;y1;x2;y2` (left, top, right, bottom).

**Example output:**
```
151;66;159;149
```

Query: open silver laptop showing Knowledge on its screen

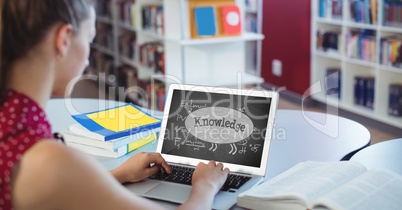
127;84;279;209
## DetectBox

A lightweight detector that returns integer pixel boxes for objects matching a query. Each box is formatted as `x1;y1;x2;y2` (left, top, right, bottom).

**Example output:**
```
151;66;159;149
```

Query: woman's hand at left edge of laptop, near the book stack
111;152;171;183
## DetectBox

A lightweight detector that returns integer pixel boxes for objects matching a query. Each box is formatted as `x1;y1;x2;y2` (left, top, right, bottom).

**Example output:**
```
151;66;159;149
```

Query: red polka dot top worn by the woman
0;90;52;210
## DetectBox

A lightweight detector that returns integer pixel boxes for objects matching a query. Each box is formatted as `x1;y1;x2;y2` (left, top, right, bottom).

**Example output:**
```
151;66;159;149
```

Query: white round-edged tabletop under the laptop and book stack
46;99;370;208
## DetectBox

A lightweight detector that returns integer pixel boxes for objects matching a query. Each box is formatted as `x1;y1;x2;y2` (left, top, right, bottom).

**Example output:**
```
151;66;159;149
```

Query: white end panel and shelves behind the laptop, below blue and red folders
161;0;264;86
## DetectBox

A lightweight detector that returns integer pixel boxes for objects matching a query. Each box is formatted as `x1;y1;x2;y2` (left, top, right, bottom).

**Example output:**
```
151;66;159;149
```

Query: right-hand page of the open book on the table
315;169;402;210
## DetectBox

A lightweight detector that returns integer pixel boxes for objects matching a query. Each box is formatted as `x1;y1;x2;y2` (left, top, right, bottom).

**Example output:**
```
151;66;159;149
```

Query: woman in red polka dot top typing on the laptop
0;0;228;210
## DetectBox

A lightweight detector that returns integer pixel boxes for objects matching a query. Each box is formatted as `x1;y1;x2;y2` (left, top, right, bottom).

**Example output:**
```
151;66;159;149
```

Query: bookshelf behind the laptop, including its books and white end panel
92;0;264;109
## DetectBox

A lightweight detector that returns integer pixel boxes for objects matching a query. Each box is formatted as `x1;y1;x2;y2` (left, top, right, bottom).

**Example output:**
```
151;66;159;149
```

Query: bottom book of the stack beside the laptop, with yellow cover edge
63;134;156;158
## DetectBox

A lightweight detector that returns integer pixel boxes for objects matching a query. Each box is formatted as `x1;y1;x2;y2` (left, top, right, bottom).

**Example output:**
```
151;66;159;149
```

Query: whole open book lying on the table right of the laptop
237;161;402;210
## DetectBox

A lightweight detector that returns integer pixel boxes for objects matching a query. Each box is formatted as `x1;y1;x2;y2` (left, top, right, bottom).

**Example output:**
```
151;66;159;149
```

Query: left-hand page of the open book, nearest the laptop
239;161;366;207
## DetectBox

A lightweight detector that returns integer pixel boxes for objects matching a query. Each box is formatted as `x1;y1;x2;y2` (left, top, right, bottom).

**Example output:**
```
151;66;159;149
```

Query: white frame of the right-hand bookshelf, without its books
310;0;402;128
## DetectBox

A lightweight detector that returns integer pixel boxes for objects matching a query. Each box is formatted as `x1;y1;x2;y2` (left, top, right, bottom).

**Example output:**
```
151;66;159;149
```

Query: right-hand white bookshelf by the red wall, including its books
310;0;402;128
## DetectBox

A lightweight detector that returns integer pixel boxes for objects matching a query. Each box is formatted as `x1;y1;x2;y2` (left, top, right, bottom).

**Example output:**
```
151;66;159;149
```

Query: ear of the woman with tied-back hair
56;24;73;58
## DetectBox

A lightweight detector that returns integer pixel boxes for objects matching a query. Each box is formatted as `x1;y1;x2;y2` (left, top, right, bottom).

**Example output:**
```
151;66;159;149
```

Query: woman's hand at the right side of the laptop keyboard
192;160;229;194
